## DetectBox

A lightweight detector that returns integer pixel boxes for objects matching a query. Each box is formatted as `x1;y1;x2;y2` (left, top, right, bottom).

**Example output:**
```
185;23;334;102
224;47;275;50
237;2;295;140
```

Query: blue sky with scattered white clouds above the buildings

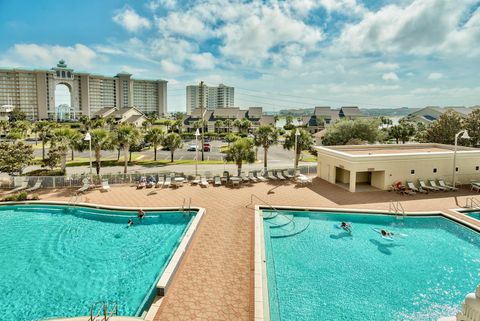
0;0;480;111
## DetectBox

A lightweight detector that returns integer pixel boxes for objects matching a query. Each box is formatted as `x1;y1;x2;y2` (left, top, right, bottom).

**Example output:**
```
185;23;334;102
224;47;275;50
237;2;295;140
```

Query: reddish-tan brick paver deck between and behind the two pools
28;179;478;321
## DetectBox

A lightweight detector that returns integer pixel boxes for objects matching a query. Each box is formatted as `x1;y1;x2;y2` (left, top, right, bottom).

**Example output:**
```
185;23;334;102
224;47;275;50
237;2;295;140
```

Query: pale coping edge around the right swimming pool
254;204;480;321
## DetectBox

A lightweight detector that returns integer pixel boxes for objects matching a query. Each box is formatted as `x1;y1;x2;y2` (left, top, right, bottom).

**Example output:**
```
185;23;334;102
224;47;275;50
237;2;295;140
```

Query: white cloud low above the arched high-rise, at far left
2;44;98;68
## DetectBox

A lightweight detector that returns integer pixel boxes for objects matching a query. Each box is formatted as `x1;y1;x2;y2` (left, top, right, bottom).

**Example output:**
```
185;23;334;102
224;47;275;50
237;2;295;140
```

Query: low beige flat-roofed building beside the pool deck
315;144;480;192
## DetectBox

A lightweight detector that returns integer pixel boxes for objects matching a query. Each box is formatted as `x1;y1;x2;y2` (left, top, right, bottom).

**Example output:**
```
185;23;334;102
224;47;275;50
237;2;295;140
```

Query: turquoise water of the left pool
0;205;195;321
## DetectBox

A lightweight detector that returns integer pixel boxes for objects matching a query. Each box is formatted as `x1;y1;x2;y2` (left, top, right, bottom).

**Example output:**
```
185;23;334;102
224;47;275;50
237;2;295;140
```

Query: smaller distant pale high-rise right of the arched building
186;84;235;115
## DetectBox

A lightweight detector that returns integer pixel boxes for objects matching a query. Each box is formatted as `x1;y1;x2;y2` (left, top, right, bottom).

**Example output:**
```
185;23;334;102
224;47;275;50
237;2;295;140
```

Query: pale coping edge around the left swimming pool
0;201;206;321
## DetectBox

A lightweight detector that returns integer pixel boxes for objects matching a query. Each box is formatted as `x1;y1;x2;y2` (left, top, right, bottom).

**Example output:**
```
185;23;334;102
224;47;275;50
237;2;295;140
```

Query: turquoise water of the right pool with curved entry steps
264;212;480;321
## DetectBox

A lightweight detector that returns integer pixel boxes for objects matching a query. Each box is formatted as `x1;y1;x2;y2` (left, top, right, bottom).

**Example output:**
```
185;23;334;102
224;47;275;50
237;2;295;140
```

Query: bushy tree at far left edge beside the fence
0;142;33;175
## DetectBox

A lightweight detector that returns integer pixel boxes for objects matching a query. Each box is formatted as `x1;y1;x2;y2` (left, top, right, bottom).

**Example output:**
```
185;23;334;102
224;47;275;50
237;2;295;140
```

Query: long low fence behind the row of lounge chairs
0;165;317;188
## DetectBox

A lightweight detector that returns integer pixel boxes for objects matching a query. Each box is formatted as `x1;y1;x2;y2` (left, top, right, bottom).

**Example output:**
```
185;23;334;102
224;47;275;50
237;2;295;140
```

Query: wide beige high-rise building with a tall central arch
0;60;167;120
